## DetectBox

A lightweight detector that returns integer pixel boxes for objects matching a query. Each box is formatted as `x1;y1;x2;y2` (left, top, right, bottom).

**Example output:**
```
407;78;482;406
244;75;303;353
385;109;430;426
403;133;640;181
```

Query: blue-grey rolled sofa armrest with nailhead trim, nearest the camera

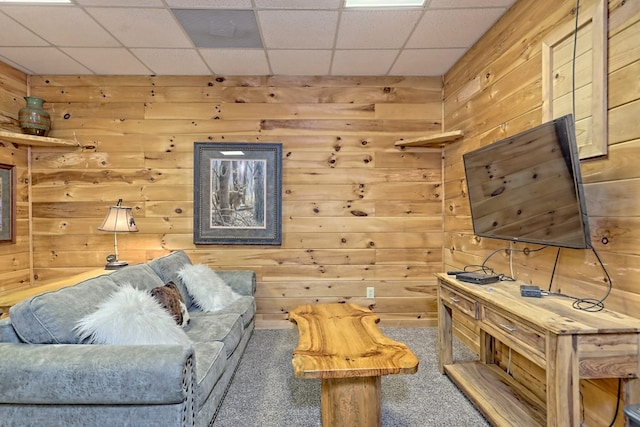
0;343;194;405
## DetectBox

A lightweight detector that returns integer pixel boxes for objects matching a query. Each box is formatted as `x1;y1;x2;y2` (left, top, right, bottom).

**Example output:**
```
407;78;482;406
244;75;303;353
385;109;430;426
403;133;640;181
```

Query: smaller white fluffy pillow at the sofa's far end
178;264;241;311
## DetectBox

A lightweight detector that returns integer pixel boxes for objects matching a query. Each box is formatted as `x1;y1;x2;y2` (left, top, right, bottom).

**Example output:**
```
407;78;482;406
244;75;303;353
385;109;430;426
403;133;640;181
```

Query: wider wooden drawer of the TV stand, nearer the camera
482;307;546;362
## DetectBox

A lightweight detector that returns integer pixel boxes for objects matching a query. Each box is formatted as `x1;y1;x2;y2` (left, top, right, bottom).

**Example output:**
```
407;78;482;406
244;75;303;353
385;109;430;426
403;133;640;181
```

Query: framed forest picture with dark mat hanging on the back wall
193;142;282;245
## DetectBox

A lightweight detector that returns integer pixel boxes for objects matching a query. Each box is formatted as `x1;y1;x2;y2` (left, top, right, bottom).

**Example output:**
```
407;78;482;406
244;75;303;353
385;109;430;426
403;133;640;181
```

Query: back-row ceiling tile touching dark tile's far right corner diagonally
267;50;331;76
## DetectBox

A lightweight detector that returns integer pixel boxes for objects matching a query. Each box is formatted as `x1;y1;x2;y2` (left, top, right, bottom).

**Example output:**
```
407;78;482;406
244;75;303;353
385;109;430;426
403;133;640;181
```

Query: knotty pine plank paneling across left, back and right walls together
0;0;640;426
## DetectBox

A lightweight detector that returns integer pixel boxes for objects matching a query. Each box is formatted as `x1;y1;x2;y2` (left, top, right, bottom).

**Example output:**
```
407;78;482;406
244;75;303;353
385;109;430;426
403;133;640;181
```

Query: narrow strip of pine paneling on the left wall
0;62;31;293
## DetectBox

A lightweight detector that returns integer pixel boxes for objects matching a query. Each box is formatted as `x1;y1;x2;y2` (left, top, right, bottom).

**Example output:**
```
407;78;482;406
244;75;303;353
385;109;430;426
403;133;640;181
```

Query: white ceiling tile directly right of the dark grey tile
258;10;338;49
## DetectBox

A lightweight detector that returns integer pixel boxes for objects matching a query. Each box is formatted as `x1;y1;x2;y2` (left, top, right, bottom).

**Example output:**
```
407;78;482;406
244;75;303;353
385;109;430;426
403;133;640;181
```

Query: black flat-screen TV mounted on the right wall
463;114;591;249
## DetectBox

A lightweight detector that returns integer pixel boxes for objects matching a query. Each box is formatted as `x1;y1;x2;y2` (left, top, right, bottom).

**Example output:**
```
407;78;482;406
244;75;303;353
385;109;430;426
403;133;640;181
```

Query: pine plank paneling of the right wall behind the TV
443;0;640;426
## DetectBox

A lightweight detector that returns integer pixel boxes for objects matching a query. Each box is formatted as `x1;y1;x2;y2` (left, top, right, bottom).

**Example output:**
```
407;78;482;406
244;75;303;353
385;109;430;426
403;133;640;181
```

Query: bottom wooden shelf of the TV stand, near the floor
444;362;547;427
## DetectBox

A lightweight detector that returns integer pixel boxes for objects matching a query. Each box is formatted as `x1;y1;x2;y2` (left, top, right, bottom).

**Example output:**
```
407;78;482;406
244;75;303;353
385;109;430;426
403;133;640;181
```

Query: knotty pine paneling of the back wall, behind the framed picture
17;76;443;327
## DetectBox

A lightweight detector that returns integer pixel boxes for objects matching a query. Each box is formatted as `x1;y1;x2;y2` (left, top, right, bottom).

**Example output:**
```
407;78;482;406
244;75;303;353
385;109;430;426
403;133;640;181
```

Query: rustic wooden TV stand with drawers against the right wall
436;273;640;427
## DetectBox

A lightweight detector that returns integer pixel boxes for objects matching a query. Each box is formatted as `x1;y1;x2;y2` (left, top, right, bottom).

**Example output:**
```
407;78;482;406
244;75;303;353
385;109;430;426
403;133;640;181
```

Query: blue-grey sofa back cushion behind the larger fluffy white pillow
9;275;118;344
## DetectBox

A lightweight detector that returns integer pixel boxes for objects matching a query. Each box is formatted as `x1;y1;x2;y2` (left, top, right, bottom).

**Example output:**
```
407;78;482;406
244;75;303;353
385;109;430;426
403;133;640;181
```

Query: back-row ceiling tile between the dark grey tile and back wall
200;49;271;76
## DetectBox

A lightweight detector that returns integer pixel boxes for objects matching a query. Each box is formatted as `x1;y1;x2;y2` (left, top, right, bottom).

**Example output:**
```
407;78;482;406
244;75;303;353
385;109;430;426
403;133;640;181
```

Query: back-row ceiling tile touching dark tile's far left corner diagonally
131;49;211;76
